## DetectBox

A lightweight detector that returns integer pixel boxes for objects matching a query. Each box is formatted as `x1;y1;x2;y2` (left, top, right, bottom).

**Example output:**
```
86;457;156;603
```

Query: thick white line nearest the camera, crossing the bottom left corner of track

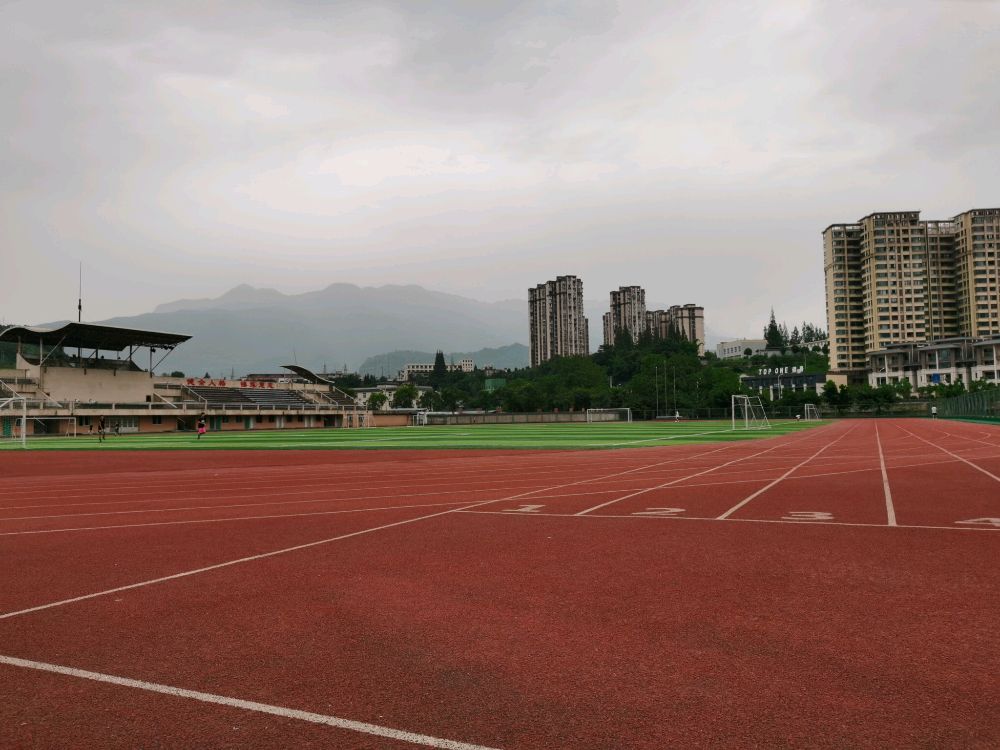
0;654;494;750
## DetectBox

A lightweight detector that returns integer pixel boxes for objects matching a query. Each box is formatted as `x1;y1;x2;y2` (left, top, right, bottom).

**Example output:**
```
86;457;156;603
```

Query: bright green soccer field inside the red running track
0;421;826;451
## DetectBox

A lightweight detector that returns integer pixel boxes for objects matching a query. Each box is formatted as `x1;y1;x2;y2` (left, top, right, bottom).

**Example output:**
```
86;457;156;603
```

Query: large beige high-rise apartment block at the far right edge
823;209;1000;380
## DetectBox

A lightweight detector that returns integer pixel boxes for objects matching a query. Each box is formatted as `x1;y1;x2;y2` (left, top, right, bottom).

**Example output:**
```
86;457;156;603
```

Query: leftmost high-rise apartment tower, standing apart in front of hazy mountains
528;276;590;367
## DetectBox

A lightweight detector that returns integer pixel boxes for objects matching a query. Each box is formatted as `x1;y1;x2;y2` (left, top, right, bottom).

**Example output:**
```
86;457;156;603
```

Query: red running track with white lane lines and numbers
0;420;1000;750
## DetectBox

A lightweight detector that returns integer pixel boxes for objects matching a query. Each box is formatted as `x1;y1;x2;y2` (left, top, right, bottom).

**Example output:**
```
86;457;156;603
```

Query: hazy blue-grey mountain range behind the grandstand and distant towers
25;283;728;377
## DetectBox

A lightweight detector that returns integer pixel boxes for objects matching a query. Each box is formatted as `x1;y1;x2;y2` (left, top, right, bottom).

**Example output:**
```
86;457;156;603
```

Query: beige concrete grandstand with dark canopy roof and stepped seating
0;323;380;437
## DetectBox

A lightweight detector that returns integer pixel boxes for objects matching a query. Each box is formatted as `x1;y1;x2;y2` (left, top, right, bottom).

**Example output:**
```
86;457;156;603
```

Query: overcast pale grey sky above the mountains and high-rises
0;0;1000;336
